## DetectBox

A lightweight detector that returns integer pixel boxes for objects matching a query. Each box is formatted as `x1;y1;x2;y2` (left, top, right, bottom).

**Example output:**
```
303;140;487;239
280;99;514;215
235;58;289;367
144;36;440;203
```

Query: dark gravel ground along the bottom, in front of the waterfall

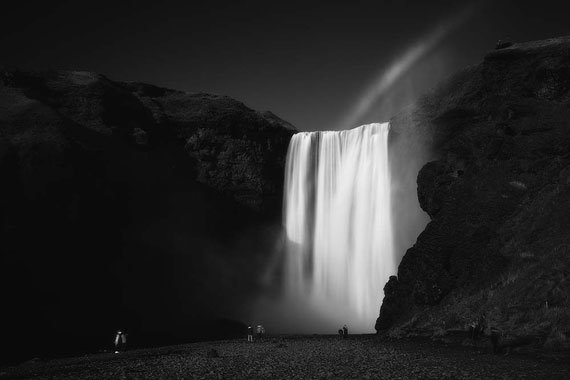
0;336;570;380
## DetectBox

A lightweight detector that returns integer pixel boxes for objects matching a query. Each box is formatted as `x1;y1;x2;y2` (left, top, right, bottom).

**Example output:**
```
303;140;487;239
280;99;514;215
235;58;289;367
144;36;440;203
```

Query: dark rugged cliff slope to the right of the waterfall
377;38;570;348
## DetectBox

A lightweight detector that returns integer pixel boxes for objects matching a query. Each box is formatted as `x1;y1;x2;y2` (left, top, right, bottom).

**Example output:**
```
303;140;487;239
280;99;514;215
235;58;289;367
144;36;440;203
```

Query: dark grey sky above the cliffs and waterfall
0;0;570;130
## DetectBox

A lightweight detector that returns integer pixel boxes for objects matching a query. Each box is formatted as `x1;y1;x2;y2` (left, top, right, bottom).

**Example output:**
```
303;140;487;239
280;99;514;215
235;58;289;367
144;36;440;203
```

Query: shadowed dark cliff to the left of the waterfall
0;72;294;360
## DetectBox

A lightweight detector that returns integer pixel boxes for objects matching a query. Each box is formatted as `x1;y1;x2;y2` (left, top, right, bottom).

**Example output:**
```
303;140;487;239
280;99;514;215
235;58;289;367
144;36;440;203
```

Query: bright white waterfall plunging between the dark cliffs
284;123;396;332
